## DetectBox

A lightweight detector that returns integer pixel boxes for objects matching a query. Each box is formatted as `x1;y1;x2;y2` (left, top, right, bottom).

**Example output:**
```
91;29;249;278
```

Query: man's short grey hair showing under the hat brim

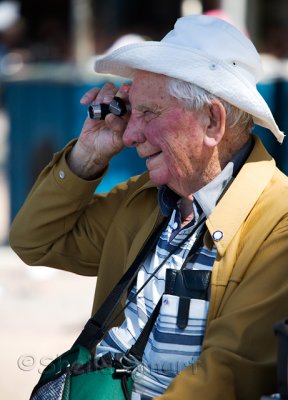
167;78;254;132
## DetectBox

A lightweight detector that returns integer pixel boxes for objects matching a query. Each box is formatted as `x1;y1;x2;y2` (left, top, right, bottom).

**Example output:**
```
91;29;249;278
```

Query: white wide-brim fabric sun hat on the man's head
95;15;284;143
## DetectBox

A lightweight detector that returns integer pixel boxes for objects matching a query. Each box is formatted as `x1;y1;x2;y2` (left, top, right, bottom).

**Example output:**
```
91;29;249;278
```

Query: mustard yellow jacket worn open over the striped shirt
10;138;288;400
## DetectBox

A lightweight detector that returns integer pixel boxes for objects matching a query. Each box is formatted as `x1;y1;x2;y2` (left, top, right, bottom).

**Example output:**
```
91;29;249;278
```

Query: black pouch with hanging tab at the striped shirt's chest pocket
164;268;211;329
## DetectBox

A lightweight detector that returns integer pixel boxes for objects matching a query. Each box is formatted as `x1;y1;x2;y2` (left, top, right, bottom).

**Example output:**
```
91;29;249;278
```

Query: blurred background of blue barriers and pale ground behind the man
0;0;288;400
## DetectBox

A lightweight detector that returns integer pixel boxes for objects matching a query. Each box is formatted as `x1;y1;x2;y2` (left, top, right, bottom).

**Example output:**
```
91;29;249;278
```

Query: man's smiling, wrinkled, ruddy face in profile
123;71;210;196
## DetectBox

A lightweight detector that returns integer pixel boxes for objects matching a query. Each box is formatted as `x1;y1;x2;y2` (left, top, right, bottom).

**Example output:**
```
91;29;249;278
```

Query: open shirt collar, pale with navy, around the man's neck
158;137;254;217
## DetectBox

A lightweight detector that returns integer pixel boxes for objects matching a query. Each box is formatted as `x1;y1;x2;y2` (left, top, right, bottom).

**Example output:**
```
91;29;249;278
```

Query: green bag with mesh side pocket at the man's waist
30;345;132;400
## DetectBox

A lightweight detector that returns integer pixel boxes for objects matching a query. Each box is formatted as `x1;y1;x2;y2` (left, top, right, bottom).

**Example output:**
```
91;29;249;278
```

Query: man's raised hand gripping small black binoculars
67;82;130;179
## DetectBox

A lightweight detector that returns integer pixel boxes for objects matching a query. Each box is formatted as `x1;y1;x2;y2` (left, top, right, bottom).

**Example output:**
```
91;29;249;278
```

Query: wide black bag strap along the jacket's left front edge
72;218;167;350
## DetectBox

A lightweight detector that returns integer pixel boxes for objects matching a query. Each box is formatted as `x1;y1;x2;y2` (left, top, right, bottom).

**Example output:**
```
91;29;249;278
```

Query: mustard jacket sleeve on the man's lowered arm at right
155;217;288;400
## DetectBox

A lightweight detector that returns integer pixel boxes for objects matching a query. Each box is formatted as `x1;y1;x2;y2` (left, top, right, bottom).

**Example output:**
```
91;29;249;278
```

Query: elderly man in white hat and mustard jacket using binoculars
10;16;288;400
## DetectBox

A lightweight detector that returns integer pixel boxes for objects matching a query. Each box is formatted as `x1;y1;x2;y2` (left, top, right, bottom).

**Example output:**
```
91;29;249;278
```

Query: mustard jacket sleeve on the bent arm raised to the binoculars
10;143;136;276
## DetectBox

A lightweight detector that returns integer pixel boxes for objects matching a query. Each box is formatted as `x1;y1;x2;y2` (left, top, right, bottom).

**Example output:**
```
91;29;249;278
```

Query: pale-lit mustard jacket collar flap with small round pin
206;136;276;256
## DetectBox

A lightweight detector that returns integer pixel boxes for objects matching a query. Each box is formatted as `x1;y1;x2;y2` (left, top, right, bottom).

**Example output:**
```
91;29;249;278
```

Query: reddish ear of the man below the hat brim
204;100;226;147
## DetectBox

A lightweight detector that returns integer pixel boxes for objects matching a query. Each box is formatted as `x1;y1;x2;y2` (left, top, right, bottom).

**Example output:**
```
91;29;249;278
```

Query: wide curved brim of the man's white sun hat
95;41;284;143
